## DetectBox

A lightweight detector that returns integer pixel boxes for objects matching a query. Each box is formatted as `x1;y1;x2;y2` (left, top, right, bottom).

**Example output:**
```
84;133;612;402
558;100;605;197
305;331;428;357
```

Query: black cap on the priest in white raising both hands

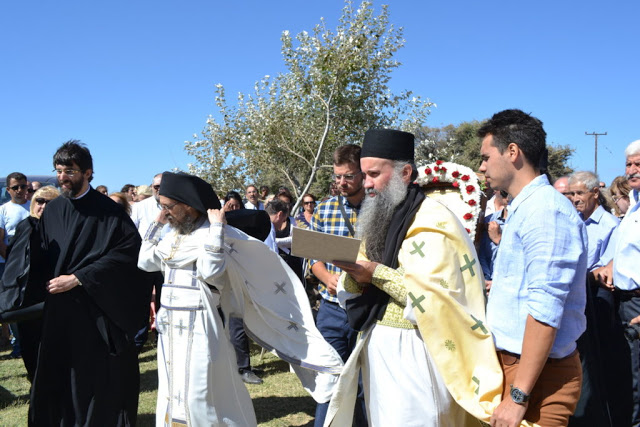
158;172;220;215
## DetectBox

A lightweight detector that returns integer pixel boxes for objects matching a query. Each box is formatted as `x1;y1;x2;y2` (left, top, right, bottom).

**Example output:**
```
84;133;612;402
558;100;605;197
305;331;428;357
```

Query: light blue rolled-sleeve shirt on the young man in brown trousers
487;175;588;358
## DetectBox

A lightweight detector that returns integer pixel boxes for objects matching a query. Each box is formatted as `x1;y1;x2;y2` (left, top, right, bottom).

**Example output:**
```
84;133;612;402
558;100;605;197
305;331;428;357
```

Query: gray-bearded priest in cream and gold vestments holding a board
325;129;502;426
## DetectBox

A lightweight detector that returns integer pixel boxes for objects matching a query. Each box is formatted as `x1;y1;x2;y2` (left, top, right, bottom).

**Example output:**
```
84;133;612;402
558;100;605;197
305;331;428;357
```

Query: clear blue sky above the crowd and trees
0;0;640;191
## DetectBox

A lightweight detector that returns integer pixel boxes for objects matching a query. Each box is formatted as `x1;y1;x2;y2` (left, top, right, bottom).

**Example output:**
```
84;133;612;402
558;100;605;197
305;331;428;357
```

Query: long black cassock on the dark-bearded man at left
29;189;151;426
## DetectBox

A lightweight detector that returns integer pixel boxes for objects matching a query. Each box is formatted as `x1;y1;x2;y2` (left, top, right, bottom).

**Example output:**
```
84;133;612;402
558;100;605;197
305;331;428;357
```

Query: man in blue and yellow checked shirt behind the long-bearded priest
309;144;367;426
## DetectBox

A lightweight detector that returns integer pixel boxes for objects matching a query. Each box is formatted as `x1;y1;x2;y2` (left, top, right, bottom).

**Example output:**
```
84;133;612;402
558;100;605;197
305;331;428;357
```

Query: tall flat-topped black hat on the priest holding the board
360;129;415;163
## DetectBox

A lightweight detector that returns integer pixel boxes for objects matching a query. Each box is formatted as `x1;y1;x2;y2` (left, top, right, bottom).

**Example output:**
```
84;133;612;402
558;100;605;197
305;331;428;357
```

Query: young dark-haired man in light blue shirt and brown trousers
478;110;587;427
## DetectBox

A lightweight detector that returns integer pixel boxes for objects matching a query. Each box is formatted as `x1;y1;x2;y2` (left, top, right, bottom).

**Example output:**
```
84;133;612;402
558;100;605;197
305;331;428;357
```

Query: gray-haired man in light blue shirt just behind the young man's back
568;171;621;426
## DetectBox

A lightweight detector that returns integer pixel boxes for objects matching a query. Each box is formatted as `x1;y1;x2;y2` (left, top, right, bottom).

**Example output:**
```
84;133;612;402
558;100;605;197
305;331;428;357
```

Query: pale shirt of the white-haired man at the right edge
611;204;640;291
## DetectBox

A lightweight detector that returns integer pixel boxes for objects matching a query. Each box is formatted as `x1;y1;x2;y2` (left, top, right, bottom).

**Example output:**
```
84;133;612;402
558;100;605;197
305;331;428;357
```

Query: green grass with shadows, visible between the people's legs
0;343;316;427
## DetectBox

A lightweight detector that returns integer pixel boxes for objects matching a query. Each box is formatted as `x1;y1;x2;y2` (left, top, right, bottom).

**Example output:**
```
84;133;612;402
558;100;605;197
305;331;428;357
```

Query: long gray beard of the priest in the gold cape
356;170;408;263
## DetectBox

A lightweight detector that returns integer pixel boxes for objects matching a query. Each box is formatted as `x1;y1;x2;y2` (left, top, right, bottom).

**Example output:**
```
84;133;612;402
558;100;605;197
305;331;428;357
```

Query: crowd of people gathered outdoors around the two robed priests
0;110;640;427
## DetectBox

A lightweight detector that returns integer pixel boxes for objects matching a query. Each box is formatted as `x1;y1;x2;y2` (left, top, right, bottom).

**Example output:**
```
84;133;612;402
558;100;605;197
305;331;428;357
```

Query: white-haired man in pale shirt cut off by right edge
594;140;640;426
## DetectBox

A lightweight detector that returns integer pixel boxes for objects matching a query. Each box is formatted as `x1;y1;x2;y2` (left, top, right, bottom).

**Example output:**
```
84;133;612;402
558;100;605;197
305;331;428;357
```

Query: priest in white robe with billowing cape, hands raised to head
138;172;342;426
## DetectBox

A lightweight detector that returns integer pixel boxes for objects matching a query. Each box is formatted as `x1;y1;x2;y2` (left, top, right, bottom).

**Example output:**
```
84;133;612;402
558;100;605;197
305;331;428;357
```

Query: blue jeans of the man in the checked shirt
314;298;368;427
